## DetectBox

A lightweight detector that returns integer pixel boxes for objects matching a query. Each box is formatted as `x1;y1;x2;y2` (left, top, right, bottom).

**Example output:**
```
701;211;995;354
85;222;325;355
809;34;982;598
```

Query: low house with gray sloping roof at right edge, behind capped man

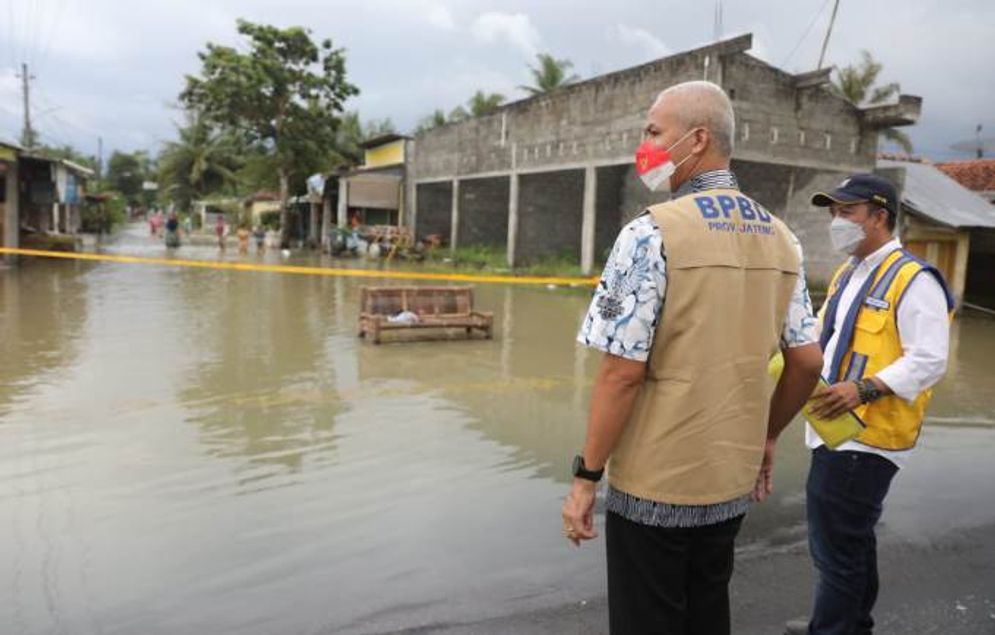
878;159;995;307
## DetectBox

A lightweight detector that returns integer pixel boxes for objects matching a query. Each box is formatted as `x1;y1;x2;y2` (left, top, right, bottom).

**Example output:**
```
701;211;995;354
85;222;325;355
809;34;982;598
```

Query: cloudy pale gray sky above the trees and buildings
0;0;995;160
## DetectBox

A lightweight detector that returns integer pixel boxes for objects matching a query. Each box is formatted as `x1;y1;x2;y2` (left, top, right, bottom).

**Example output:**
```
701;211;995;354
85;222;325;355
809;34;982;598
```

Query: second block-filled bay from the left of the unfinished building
459;177;509;247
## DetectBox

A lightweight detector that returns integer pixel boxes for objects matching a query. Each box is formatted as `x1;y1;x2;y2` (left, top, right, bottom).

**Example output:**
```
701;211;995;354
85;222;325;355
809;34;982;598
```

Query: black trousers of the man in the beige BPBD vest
605;512;743;635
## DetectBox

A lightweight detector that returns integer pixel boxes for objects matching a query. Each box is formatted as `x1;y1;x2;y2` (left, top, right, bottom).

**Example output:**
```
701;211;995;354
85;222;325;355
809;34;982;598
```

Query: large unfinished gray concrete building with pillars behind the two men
404;34;921;284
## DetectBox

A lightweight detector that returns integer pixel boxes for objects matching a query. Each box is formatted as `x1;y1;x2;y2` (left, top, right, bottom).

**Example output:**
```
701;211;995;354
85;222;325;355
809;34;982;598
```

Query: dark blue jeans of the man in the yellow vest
806;447;898;635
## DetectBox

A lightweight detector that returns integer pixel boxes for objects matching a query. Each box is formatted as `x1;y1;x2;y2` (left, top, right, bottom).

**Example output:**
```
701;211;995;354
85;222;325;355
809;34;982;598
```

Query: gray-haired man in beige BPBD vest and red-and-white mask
563;82;822;635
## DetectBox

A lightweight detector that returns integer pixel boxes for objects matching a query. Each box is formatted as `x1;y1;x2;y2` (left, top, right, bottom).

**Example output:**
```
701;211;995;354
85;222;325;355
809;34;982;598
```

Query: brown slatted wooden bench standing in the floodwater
359;287;494;344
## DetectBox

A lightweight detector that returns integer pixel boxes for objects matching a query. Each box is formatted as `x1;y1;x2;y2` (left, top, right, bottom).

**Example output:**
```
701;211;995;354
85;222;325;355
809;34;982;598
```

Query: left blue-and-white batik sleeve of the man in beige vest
577;214;667;362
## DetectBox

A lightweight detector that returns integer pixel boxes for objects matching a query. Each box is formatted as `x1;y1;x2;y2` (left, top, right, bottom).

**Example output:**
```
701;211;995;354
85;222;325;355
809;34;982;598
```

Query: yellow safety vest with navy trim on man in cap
821;249;954;450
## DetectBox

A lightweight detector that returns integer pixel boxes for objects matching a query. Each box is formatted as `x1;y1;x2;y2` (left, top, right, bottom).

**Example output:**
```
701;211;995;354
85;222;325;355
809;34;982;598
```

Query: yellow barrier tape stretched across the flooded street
0;247;598;286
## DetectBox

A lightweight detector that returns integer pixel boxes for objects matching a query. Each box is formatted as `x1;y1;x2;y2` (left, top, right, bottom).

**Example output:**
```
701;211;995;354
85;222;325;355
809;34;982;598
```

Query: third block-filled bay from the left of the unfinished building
515;170;584;265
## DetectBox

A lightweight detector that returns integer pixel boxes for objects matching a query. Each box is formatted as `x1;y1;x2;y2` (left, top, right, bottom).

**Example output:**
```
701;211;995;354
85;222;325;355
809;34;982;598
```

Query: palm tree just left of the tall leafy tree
158;112;245;210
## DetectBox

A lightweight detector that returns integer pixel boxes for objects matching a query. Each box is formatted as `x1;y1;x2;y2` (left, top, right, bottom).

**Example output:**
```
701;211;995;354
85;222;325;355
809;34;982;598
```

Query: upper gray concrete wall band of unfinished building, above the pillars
413;42;877;180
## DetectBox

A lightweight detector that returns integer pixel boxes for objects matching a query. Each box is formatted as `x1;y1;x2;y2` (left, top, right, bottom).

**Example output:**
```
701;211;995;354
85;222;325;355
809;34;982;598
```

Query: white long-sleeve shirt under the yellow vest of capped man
805;238;950;467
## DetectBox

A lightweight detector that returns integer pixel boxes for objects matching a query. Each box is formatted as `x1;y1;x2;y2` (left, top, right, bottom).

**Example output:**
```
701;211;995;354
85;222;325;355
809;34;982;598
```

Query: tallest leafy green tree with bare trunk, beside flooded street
180;20;359;244
